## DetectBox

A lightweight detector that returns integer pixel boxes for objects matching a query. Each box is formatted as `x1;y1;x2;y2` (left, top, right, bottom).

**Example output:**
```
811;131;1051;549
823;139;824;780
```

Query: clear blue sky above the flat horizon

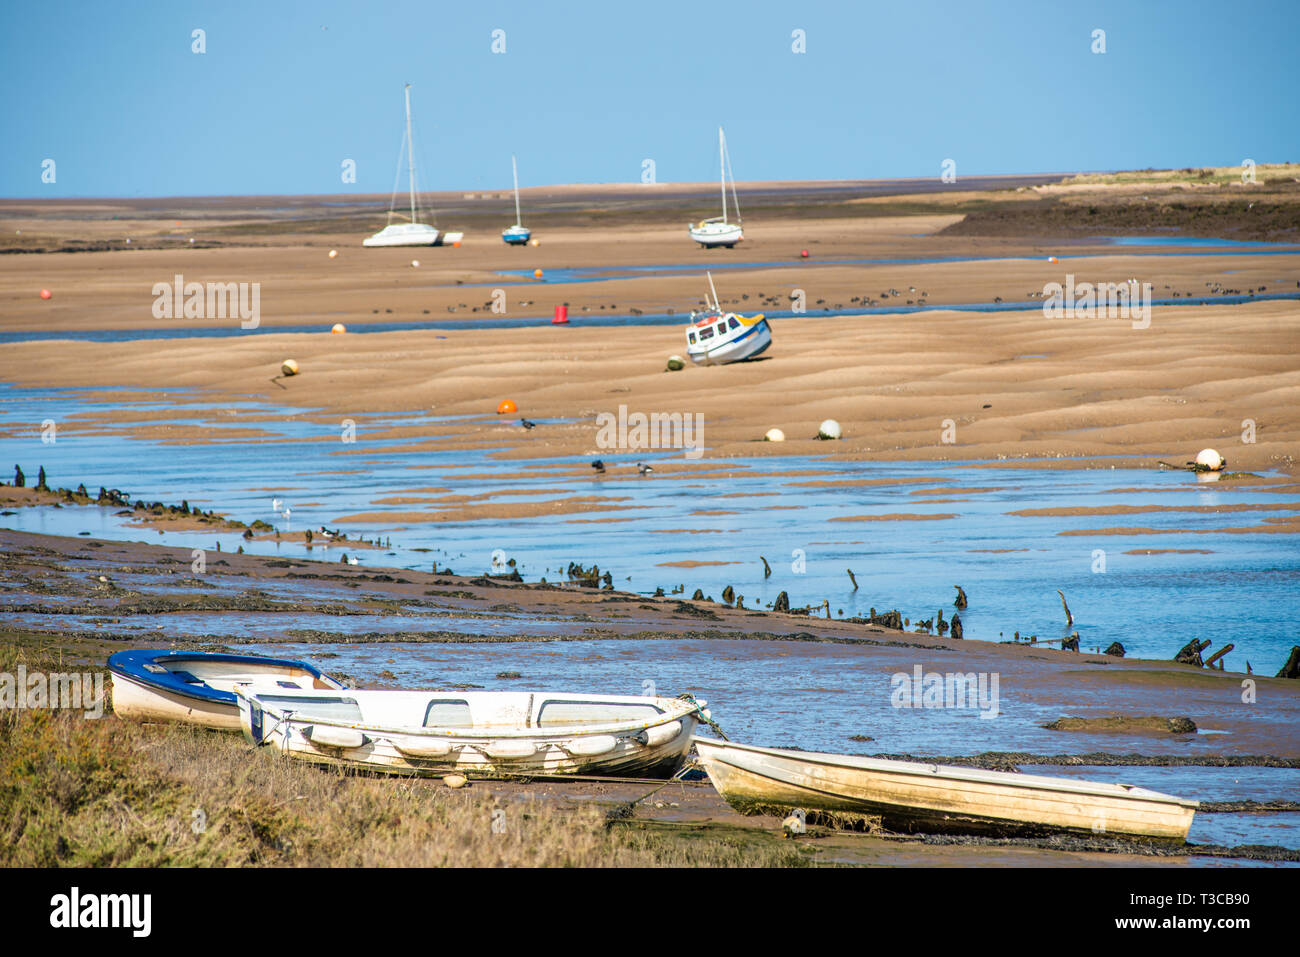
0;0;1300;198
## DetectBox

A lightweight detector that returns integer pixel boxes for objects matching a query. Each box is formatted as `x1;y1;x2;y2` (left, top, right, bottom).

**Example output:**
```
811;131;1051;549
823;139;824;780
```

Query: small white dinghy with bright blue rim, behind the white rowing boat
108;648;343;731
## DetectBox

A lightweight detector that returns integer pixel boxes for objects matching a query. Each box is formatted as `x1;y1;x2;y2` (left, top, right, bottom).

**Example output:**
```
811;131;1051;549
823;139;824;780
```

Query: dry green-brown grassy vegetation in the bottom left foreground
0;637;814;867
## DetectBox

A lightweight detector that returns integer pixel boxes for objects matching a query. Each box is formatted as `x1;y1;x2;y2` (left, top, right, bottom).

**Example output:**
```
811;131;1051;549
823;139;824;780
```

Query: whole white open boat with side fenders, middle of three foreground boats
237;689;707;778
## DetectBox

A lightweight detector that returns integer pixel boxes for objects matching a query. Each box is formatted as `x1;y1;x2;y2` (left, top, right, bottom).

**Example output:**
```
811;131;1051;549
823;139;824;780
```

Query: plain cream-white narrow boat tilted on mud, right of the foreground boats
696;737;1197;841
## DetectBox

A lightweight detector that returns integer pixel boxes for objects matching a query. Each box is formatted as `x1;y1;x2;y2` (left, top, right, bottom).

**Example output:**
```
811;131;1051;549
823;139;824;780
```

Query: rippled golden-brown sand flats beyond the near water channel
0;178;1300;473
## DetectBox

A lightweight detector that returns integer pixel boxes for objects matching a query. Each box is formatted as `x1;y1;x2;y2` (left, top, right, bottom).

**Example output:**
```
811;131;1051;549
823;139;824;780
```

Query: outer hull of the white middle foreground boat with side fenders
239;692;697;779
